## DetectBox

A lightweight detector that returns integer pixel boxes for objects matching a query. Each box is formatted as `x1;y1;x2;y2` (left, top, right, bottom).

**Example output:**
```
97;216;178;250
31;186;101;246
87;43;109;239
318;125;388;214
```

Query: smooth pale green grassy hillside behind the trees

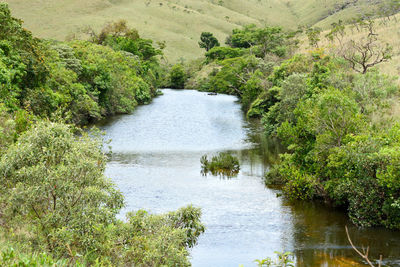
0;0;388;61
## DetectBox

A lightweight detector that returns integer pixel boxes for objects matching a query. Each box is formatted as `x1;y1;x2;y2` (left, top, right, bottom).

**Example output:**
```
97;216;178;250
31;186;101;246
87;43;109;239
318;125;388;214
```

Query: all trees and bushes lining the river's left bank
0;3;204;266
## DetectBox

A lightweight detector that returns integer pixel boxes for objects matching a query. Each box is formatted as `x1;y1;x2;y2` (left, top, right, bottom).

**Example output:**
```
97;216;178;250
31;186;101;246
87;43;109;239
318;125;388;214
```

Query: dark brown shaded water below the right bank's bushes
283;202;400;267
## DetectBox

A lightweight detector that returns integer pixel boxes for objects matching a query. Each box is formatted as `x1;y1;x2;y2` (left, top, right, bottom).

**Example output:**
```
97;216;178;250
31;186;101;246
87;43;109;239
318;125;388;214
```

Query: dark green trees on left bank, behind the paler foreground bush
0;3;161;124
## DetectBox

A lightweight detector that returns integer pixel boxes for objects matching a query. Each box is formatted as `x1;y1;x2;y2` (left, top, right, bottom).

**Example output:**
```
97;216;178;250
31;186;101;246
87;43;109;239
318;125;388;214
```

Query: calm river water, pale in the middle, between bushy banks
101;89;400;267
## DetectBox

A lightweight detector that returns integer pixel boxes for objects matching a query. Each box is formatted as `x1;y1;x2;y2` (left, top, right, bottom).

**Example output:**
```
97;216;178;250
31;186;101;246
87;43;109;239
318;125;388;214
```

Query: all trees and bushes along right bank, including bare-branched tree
185;17;400;229
